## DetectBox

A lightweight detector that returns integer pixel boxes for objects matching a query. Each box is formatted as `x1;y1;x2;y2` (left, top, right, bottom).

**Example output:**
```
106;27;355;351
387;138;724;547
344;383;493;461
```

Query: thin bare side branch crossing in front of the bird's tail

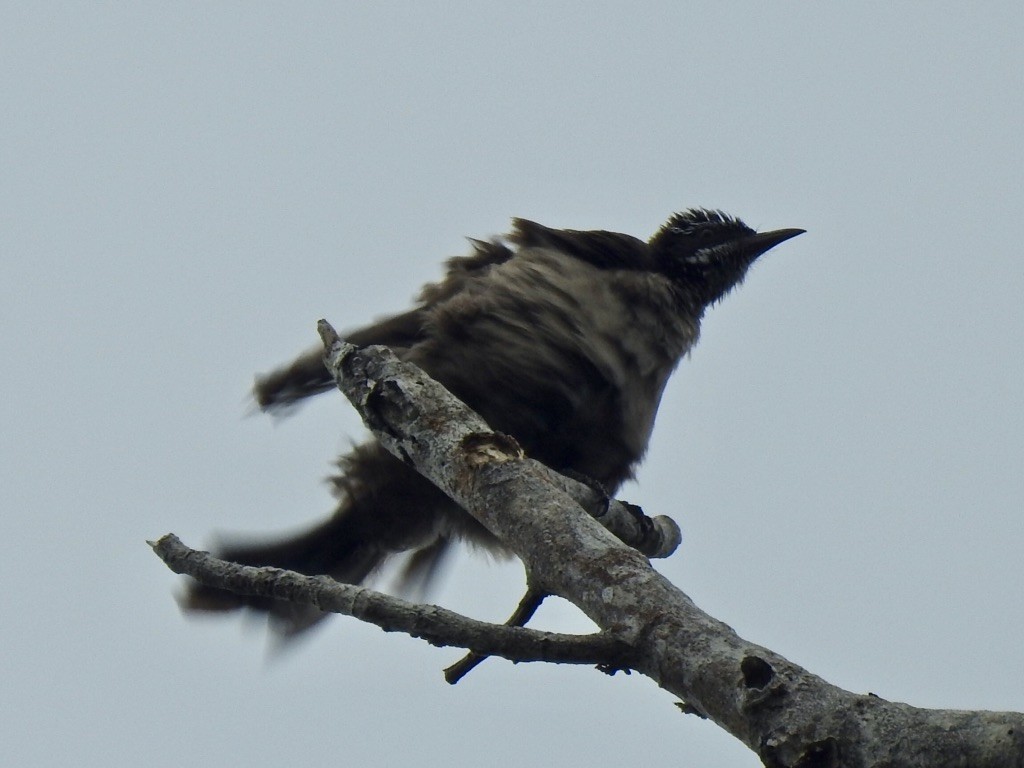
150;534;630;669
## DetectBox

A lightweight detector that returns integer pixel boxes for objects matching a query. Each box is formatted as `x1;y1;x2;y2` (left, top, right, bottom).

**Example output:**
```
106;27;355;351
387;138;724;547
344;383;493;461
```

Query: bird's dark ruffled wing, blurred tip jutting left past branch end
253;240;515;414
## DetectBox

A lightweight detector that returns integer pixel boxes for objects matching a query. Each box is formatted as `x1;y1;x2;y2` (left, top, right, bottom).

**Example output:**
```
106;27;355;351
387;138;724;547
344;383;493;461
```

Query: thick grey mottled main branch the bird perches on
151;321;1024;768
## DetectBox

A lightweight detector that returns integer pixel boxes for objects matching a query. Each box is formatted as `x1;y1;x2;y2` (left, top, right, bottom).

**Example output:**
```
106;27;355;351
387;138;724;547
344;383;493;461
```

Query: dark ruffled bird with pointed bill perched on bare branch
181;208;805;639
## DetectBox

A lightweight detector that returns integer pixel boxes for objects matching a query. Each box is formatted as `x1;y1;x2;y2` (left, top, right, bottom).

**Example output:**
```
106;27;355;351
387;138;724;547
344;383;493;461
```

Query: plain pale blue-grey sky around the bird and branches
0;0;1024;768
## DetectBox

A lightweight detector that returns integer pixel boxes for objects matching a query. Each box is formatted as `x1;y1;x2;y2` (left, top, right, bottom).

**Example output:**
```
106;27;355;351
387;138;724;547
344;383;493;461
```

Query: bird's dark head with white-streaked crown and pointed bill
649;208;804;308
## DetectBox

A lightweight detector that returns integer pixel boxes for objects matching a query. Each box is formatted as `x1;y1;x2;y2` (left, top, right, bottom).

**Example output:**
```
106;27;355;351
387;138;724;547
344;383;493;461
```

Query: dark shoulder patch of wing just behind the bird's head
509;219;654;271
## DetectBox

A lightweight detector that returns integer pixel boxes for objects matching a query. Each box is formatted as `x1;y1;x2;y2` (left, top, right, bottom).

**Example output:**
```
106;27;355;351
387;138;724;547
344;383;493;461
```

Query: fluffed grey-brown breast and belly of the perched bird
411;249;697;484
